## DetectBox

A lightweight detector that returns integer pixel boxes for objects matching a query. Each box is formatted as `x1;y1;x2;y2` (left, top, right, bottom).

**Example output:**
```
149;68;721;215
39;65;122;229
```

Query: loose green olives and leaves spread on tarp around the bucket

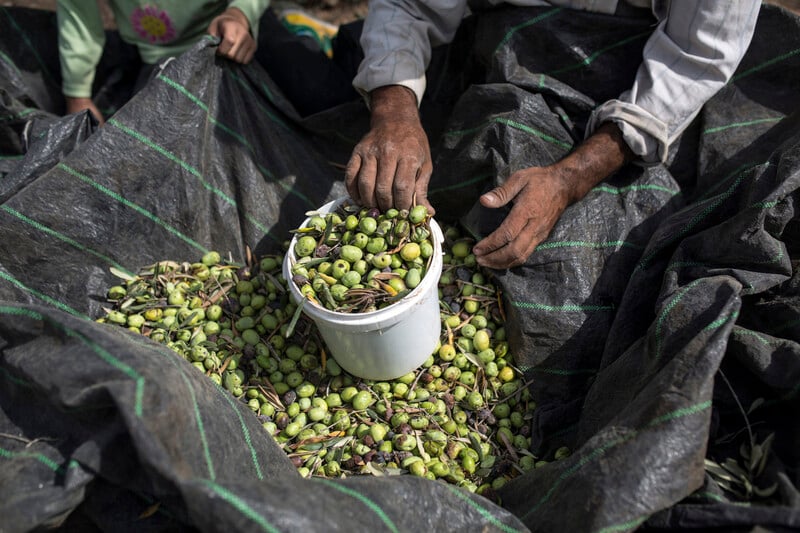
98;222;569;497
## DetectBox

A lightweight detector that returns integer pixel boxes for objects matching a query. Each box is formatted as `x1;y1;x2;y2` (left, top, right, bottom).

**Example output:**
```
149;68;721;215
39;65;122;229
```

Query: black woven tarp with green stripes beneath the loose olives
0;5;800;532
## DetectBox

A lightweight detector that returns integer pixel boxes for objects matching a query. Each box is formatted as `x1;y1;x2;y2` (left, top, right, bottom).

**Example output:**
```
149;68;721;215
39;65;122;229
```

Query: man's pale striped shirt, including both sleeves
353;0;761;164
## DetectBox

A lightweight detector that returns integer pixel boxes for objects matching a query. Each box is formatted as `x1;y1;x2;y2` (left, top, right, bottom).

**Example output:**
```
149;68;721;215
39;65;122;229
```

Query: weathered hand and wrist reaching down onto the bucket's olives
345;85;434;214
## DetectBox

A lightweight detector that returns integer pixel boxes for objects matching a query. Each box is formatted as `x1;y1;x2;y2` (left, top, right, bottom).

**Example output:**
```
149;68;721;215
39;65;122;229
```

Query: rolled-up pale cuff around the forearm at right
586;100;669;165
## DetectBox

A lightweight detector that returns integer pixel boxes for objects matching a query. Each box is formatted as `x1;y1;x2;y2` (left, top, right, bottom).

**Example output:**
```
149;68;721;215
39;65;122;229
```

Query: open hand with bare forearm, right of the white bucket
472;123;633;269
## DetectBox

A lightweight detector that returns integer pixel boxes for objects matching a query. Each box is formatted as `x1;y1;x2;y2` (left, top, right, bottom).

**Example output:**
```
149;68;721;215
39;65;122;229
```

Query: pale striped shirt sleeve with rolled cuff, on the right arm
586;0;761;164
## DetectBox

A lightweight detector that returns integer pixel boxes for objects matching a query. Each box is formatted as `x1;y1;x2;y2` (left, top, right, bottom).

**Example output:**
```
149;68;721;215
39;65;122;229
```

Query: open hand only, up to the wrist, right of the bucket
472;166;572;269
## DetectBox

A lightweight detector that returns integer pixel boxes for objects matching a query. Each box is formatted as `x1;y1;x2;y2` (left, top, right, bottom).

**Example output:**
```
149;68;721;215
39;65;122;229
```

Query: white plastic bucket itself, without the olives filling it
283;198;444;381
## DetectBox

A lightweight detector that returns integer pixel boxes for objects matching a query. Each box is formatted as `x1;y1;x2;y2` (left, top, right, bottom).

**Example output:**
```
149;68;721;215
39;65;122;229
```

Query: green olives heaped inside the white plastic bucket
291;202;434;313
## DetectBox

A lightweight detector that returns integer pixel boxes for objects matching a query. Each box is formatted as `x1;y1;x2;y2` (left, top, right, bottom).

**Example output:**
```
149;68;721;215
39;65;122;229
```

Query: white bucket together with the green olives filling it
283;198;444;380
